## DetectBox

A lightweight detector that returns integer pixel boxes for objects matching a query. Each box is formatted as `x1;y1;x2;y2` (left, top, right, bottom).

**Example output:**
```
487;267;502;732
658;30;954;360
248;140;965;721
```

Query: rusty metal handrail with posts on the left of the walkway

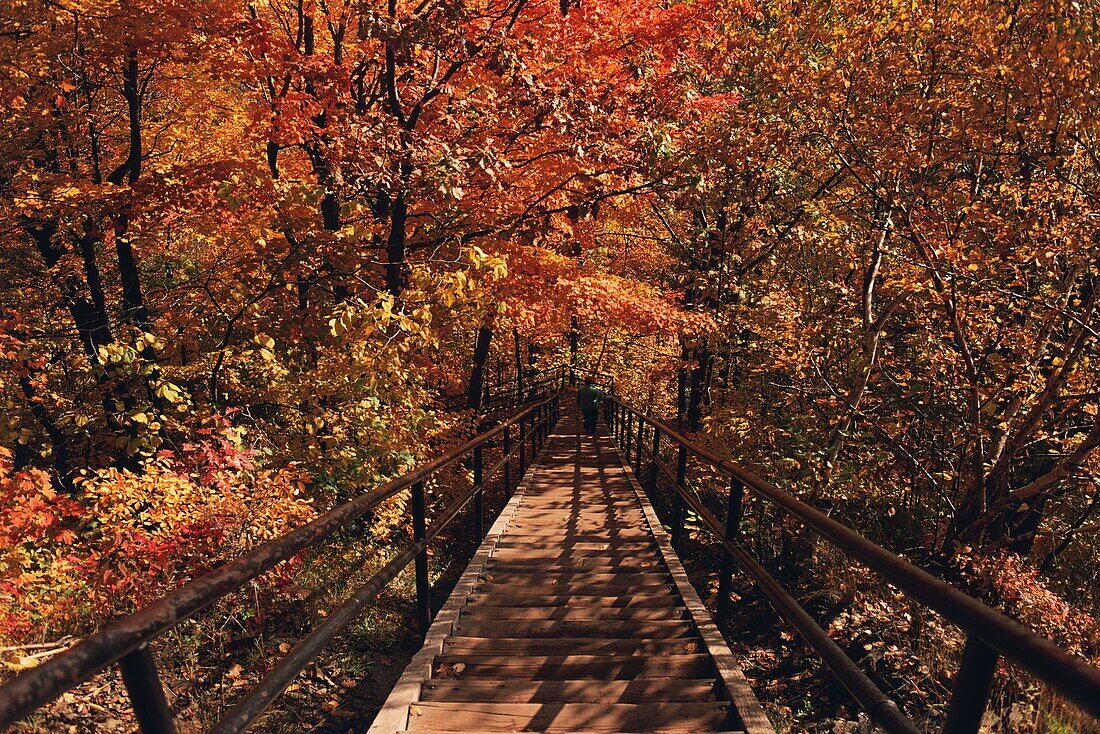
0;394;560;734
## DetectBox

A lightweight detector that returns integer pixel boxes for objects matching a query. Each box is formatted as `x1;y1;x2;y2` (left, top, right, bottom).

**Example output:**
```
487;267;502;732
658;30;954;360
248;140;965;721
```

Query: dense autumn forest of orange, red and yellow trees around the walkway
0;0;1100;732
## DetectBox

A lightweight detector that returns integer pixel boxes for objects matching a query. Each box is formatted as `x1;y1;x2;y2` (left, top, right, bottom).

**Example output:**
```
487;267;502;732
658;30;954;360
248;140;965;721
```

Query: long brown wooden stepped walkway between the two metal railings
370;415;772;734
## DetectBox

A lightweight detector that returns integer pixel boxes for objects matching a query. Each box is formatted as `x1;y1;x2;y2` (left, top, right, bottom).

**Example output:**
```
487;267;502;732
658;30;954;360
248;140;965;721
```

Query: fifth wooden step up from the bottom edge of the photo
452;620;696;639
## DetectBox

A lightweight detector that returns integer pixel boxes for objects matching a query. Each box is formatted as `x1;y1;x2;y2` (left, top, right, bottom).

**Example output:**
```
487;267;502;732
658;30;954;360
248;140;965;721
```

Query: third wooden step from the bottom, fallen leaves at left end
432;651;714;680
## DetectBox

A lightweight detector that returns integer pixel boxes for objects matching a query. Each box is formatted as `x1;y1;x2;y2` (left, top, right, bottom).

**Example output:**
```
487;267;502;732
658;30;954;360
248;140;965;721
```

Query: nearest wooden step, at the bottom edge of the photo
408;701;730;733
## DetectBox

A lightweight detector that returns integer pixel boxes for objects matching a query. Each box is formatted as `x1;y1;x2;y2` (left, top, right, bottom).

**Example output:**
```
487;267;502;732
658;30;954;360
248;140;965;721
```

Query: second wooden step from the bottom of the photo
420;678;718;703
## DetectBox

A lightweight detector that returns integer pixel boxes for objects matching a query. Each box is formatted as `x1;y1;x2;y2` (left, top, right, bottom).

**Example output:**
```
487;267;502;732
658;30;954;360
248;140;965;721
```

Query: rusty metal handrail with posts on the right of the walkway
608;397;1100;734
